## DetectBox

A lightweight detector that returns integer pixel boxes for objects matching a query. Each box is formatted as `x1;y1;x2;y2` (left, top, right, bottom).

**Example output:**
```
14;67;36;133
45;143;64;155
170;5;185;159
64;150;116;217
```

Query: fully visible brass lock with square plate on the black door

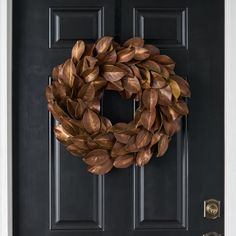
204;199;220;219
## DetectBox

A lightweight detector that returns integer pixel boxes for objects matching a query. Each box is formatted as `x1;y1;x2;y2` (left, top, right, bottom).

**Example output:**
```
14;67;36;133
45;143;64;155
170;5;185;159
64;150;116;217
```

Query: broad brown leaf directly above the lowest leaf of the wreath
83;149;110;166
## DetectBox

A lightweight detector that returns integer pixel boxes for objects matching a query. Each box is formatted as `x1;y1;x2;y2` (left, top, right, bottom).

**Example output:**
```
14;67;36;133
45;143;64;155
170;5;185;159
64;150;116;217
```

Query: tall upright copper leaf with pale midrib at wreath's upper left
62;59;76;88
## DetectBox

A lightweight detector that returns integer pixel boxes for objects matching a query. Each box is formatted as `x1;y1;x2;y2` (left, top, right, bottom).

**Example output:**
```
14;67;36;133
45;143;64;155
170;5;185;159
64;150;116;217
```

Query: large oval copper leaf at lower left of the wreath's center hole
82;109;101;134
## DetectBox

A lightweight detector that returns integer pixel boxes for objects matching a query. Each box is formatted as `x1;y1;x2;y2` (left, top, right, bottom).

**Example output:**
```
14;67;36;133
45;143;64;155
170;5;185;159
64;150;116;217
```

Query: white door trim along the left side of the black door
0;0;13;236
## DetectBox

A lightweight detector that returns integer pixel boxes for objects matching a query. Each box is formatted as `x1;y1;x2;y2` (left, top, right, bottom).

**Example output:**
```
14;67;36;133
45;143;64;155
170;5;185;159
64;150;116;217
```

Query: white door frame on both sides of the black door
0;0;236;236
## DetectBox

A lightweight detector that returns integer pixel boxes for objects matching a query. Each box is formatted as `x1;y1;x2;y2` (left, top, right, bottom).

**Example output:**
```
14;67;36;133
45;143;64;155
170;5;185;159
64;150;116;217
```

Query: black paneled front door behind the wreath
13;0;224;236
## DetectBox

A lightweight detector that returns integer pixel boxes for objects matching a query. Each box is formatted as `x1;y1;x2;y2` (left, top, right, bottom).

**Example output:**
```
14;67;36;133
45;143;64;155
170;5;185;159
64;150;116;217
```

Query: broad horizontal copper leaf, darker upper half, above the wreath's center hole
103;65;126;82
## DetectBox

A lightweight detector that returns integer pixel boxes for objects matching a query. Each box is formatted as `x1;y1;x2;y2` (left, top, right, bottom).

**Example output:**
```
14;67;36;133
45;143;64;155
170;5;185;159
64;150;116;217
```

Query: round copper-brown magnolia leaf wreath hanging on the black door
46;36;190;175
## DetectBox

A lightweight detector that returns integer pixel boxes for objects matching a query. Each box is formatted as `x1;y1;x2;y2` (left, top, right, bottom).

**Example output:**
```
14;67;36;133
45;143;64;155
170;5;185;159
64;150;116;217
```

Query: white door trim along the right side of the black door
225;0;236;236
